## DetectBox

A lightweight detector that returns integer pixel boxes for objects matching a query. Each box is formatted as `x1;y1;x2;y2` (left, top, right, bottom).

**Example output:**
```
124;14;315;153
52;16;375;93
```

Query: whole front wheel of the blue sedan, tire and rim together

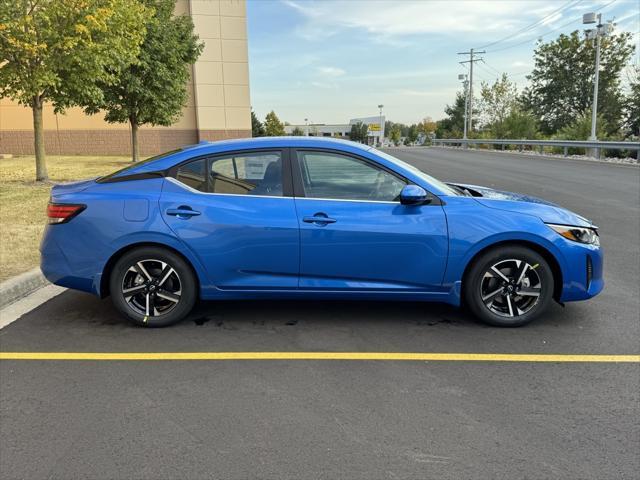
462;246;554;327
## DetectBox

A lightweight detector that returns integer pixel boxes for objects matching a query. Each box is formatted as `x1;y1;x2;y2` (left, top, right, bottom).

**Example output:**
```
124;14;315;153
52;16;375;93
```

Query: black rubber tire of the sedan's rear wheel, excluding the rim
109;247;197;327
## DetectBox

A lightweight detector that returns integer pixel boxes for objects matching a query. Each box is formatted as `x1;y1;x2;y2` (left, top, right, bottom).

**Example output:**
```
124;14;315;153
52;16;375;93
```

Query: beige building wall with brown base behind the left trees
0;0;251;155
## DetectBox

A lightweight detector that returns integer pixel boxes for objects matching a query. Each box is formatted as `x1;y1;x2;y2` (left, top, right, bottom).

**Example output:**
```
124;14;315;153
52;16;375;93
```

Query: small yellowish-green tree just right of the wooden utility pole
478;73;518;138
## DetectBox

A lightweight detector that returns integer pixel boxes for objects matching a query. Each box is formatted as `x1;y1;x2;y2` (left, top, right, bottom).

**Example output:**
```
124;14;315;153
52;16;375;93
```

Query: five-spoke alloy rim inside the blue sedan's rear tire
122;259;182;318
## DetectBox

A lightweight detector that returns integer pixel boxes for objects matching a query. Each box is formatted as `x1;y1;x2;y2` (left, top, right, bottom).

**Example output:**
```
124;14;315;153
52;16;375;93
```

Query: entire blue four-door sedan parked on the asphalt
41;137;604;327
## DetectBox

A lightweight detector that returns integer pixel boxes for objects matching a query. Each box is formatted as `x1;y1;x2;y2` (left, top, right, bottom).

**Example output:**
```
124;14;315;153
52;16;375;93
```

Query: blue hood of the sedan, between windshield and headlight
450;183;595;228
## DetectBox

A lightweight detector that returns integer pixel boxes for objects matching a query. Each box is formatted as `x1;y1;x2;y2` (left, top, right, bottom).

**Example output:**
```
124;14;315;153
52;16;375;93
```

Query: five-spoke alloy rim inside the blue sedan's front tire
480;259;542;317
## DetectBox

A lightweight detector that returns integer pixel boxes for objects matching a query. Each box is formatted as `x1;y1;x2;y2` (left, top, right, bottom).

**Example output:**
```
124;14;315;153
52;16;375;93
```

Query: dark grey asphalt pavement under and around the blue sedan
0;148;640;479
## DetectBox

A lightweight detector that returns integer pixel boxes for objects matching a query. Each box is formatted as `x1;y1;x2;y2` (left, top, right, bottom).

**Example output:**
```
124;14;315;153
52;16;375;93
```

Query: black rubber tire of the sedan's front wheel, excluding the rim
463;246;554;327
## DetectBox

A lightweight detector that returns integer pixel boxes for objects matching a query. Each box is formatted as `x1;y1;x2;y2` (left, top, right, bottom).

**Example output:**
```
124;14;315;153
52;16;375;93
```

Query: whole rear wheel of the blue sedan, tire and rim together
109;247;197;327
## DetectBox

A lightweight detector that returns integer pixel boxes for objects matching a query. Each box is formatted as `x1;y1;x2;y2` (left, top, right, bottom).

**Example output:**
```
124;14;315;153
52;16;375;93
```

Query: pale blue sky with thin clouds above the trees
247;0;640;124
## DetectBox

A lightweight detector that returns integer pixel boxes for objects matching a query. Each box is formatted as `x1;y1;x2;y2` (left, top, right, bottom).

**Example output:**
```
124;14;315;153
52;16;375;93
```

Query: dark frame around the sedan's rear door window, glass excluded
166;147;294;198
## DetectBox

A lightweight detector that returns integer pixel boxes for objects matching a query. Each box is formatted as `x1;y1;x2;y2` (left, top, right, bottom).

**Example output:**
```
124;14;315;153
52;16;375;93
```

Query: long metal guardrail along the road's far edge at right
431;138;640;160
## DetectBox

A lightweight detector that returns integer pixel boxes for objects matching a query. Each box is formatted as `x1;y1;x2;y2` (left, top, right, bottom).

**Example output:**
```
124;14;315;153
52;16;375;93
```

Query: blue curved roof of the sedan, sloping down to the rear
110;136;373;178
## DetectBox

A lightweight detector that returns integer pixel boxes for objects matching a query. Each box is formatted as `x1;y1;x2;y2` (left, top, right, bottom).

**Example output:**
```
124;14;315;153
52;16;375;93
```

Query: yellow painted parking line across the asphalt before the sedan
0;352;640;363
